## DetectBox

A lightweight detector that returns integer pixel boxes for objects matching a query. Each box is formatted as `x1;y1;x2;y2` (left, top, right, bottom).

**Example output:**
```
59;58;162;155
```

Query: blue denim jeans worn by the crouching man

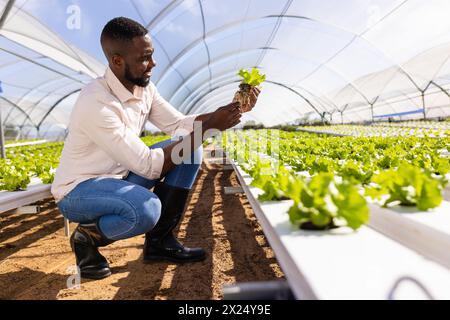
57;140;203;240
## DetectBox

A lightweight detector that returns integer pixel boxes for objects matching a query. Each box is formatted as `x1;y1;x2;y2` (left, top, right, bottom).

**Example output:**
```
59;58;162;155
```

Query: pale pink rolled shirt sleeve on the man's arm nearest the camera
79;100;164;179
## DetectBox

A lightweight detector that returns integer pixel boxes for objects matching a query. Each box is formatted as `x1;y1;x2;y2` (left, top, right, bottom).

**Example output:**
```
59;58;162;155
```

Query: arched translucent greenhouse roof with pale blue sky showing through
0;0;450;138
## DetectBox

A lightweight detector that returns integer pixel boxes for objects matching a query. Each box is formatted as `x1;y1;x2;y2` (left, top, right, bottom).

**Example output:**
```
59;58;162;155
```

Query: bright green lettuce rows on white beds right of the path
219;130;450;229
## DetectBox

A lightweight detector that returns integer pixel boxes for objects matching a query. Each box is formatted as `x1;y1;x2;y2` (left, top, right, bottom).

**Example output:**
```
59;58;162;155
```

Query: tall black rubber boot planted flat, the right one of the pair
144;182;206;262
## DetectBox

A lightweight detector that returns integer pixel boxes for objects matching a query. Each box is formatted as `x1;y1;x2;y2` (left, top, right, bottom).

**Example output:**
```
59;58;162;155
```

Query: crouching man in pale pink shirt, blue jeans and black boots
51;17;257;279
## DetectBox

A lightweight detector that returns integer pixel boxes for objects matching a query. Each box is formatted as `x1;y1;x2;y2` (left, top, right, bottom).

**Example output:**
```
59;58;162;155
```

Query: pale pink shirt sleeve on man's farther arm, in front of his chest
148;84;198;136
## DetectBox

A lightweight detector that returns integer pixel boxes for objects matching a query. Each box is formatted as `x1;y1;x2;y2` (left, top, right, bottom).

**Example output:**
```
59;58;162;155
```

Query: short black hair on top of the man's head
100;17;148;43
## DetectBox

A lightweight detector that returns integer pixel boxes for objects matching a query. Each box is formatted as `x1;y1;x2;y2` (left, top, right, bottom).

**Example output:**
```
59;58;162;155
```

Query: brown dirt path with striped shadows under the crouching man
0;159;283;299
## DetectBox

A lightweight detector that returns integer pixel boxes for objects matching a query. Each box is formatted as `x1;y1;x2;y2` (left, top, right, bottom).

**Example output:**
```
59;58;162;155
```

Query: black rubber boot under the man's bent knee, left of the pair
70;223;114;279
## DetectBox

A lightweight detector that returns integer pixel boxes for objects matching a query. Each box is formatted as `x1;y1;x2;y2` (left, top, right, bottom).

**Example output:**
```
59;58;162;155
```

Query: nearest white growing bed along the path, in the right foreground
231;156;450;299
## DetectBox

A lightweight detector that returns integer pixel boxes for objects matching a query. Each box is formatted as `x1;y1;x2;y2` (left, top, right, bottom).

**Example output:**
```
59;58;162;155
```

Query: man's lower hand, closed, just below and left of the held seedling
203;102;242;131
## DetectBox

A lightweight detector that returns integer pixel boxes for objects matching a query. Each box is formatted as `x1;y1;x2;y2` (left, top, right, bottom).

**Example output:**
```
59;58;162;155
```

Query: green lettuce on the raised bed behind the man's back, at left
0;136;168;191
